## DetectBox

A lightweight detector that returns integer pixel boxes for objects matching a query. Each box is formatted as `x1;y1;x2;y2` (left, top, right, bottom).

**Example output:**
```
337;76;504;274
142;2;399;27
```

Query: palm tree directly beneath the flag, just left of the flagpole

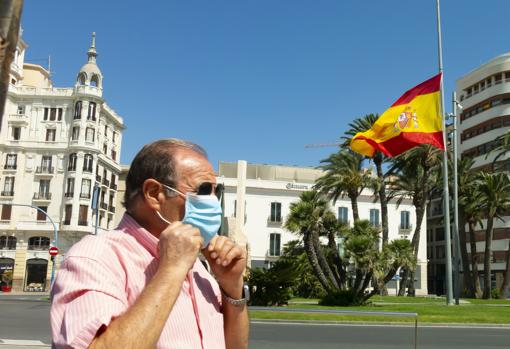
388;145;442;296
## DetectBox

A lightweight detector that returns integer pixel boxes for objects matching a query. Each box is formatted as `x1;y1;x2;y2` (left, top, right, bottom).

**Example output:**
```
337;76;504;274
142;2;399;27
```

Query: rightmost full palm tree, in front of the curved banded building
477;172;510;299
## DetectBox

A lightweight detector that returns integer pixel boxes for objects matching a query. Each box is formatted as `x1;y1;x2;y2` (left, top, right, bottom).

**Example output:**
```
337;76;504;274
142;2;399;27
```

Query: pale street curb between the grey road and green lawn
250;318;510;329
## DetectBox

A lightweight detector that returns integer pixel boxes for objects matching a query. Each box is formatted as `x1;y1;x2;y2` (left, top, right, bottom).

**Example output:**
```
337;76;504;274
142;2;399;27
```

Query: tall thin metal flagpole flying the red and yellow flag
436;0;454;305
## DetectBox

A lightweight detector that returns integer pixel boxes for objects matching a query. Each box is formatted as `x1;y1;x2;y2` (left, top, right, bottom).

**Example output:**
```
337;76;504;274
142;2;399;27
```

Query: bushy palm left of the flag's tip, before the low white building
314;149;372;221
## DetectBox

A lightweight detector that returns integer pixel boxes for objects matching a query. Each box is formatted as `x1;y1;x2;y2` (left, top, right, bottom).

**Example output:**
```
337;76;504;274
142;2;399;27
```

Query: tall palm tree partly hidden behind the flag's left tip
342;114;389;246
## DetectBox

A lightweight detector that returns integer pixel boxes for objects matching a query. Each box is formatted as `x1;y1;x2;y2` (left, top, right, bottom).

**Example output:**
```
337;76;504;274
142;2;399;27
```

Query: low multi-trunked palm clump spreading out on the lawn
285;191;414;304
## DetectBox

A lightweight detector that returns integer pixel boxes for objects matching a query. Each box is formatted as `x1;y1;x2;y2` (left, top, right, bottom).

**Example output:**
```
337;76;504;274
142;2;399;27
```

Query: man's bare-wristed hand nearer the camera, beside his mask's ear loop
158;222;204;273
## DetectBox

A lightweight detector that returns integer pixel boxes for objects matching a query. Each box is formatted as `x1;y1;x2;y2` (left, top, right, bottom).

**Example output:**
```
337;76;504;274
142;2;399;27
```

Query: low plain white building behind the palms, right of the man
217;161;427;295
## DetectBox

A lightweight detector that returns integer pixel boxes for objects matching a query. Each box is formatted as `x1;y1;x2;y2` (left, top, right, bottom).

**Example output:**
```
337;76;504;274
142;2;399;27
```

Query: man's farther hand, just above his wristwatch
202;235;246;298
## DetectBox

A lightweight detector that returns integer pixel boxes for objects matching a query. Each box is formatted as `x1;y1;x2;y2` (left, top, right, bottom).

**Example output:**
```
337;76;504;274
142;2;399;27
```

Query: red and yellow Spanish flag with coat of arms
351;73;444;157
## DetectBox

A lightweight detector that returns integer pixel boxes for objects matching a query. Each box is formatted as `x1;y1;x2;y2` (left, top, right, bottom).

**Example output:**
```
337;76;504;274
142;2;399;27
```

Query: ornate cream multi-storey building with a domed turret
0;34;124;291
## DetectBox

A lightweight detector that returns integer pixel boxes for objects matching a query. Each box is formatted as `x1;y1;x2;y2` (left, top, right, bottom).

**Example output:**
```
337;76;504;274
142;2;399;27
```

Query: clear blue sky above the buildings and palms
22;0;510;166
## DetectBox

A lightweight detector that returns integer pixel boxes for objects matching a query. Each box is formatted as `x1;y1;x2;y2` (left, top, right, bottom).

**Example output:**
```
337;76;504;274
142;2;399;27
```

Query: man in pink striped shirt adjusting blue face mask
51;139;249;349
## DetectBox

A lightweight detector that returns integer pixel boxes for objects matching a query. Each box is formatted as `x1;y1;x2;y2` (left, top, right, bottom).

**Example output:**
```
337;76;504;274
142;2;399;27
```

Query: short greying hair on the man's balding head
123;138;207;212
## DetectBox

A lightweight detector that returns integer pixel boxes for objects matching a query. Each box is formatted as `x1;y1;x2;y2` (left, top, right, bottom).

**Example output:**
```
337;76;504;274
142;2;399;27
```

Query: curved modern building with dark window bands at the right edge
456;53;510;287
